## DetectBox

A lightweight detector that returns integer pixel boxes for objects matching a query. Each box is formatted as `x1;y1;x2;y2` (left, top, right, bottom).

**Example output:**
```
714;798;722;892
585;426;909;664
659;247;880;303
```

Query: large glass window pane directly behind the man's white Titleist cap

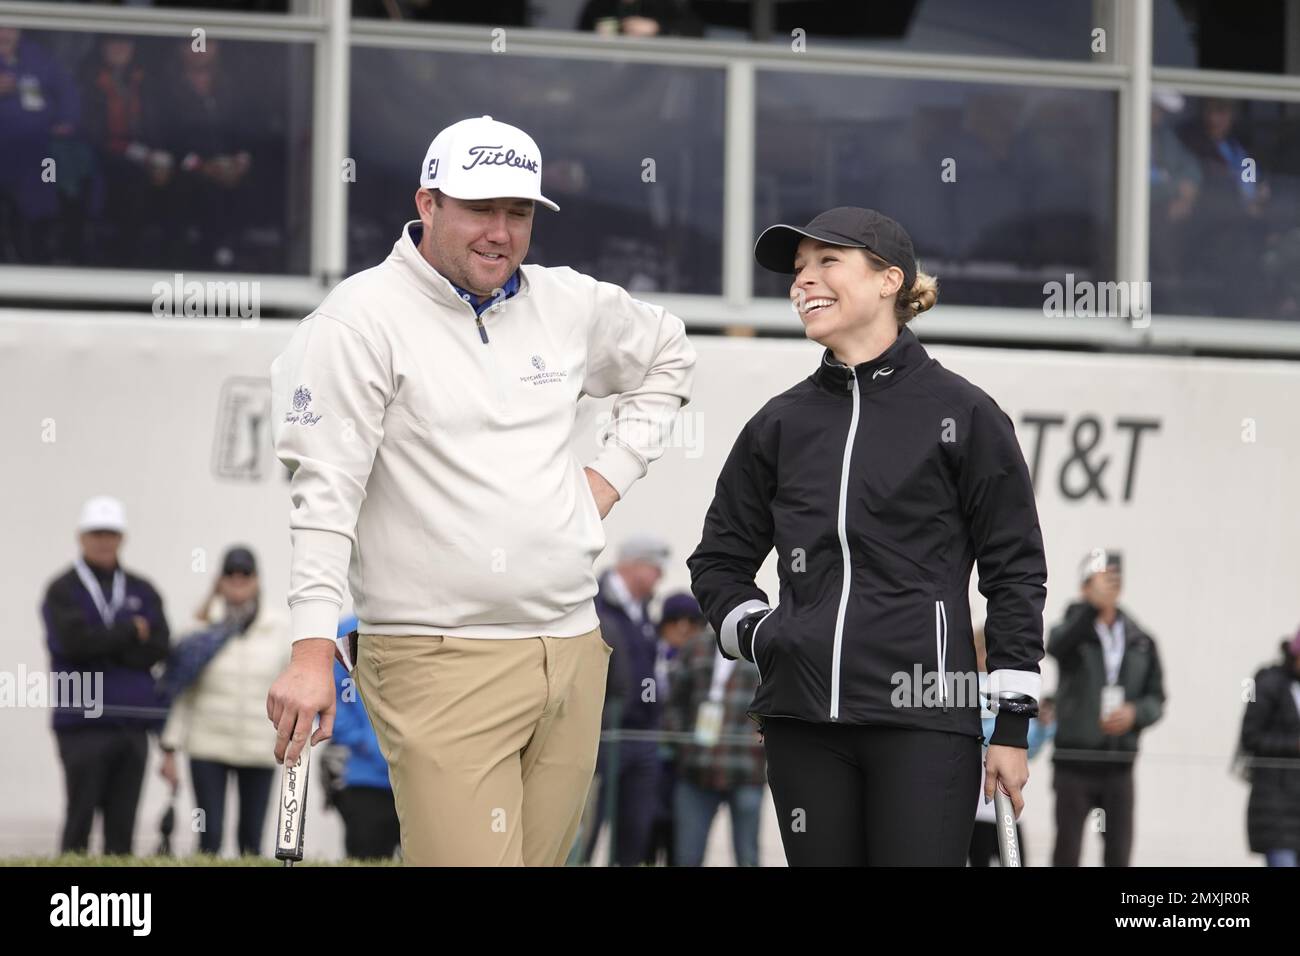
348;47;724;294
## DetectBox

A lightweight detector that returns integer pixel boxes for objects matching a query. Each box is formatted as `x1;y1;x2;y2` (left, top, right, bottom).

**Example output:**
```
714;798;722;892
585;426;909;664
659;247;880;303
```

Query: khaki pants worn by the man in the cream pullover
356;630;611;866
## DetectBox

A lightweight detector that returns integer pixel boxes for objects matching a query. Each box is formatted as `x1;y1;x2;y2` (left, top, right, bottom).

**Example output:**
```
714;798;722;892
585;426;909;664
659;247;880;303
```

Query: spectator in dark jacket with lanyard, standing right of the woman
1048;551;1165;866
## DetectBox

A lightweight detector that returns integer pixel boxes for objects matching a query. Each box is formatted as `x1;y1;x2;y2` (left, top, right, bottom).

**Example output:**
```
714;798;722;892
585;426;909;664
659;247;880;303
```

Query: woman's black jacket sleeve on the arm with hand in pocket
686;421;776;659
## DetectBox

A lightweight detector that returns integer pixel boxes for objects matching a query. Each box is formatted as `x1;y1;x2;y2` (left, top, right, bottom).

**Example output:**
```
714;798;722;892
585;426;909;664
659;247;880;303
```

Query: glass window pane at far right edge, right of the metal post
1151;95;1300;319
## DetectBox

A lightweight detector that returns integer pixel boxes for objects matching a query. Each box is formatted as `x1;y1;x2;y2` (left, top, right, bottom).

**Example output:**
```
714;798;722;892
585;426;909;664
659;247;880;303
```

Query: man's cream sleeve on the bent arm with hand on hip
582;280;696;496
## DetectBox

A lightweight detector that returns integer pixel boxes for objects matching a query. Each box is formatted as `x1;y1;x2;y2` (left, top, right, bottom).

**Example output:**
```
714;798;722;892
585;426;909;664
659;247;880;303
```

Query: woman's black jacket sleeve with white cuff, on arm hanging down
958;399;1048;748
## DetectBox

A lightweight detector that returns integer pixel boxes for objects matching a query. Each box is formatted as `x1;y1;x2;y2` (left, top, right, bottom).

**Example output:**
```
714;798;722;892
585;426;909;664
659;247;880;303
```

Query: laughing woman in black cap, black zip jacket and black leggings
688;207;1047;866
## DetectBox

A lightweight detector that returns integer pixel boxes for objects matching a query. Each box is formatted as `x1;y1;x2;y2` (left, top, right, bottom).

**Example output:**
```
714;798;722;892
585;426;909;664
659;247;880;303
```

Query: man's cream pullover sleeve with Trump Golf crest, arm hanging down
270;312;393;641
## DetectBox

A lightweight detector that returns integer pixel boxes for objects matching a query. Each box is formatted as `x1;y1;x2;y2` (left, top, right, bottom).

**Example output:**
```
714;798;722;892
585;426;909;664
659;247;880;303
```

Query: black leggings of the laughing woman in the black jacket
763;717;983;866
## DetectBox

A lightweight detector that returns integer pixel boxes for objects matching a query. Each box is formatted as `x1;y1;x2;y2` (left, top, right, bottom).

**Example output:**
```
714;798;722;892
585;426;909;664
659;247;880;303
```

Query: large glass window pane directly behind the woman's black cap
754;70;1117;308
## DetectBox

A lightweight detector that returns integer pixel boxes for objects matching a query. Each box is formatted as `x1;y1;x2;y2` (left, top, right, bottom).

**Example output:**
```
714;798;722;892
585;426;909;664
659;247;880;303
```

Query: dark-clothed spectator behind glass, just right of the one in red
159;38;254;269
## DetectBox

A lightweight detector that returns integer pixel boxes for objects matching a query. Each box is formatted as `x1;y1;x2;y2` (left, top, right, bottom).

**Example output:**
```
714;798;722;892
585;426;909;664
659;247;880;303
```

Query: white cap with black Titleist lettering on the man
420;116;560;212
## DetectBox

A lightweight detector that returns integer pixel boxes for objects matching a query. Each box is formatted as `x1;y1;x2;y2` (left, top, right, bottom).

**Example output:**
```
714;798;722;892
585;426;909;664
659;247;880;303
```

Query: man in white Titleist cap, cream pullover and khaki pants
267;116;696;865
